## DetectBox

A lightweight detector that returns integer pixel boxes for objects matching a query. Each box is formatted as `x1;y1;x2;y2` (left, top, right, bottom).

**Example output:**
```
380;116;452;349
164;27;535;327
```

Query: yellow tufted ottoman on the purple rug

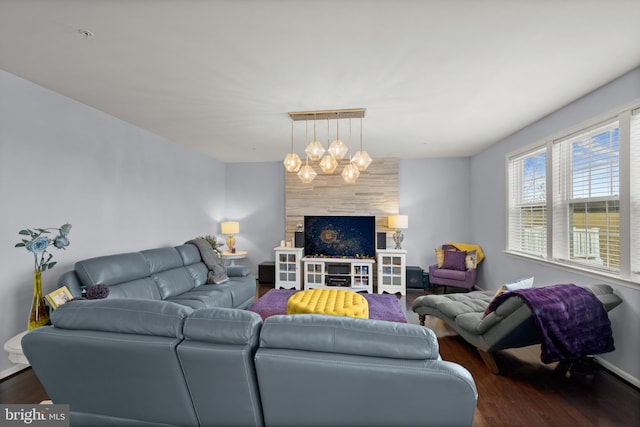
287;289;369;319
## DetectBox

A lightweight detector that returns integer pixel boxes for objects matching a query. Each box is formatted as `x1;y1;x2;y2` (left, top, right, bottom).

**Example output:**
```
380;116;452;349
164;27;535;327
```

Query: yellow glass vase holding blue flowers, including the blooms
15;224;71;330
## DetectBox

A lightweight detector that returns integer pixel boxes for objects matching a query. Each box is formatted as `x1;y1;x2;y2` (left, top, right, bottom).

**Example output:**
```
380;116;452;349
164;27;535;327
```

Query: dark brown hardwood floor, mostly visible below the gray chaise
0;286;640;427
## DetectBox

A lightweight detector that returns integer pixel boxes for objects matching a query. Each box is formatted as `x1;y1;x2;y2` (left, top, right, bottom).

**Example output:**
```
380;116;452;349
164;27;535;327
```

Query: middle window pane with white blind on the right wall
552;120;620;271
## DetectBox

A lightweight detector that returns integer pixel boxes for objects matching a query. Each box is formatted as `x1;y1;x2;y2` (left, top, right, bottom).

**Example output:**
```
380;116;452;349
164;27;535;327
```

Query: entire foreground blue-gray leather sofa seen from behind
22;298;478;427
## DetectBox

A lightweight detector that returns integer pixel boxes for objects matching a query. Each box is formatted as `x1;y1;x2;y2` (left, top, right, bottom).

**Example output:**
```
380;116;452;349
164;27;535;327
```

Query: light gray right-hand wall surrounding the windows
470;68;640;384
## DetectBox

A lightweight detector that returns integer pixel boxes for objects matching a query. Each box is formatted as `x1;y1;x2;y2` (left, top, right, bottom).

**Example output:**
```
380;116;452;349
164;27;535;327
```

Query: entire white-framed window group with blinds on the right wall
507;104;640;283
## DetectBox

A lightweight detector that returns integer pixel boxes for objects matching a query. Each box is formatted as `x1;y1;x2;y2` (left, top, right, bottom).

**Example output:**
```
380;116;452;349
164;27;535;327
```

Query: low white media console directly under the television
302;257;375;293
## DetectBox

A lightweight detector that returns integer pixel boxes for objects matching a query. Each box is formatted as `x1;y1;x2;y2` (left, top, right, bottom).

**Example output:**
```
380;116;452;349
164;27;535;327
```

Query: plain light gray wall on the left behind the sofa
0;71;226;378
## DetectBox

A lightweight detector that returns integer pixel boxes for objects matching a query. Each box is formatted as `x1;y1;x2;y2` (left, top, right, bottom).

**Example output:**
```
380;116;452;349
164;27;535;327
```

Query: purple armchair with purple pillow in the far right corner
429;244;478;292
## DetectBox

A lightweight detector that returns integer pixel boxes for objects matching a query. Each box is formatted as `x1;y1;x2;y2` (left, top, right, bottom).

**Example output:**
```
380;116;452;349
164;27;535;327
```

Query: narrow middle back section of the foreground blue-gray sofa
178;308;264;427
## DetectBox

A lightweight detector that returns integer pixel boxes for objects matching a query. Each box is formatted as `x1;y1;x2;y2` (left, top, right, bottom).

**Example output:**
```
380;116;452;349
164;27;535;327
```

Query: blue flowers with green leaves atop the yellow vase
15;224;71;271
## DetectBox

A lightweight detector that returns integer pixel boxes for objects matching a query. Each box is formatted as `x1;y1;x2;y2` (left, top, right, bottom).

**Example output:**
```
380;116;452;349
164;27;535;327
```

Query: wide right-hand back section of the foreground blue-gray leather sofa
255;314;477;427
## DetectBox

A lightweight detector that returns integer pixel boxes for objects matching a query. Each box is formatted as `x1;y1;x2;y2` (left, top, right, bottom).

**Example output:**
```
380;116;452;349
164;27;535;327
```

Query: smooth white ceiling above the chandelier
0;0;640;162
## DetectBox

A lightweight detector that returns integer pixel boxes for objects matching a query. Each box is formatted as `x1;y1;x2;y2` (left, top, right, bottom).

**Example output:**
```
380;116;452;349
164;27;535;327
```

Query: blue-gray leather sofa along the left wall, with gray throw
58;243;256;308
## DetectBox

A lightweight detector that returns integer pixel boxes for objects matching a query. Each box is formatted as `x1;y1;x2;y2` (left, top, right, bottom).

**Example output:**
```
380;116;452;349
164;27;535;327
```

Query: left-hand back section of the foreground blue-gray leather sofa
23;299;200;427
